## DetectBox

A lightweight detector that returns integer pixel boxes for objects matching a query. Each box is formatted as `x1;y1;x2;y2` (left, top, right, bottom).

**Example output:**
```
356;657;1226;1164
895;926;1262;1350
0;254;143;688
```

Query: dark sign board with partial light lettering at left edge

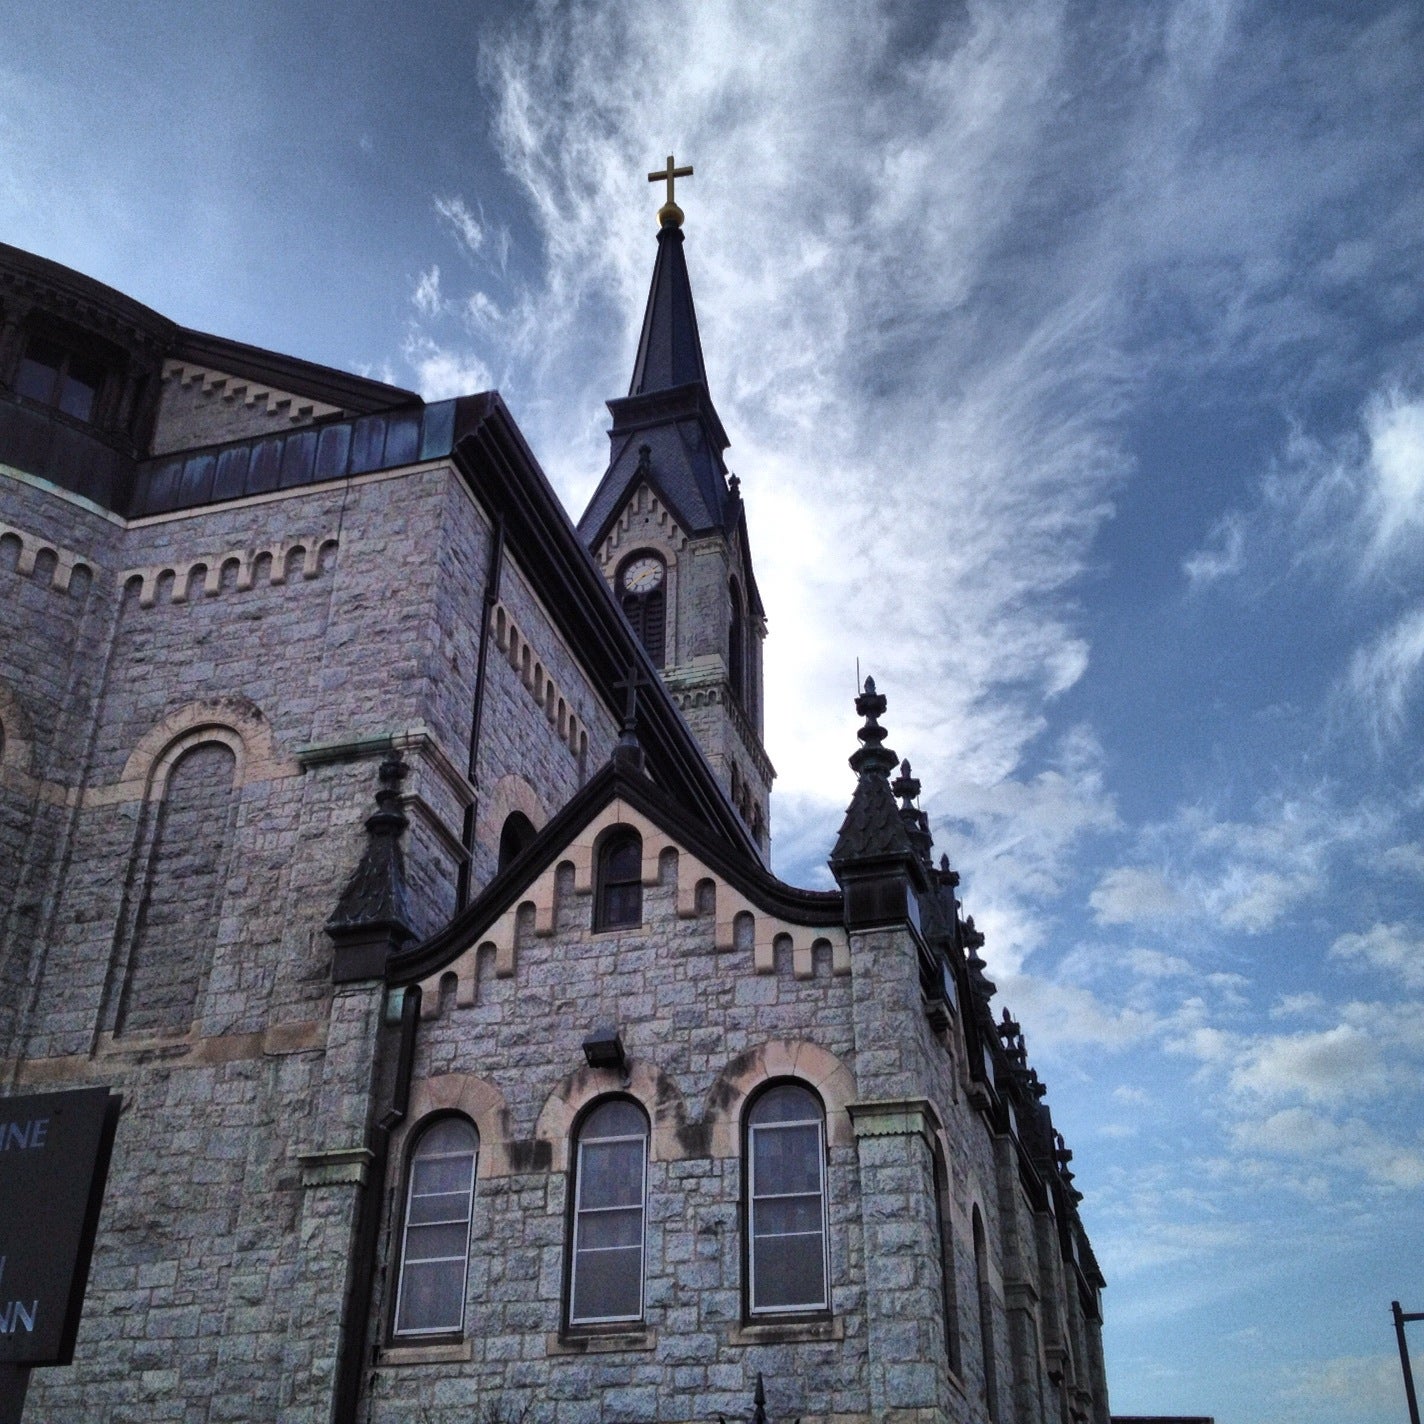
0;1088;120;1367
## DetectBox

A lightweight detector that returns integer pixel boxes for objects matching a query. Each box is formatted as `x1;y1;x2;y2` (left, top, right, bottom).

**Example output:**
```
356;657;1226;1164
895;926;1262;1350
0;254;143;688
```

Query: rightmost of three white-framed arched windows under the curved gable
746;1084;830;1316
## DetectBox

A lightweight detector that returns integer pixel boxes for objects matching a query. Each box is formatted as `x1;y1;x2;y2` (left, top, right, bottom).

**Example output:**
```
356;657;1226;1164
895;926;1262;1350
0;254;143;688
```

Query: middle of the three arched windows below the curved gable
568;1098;648;1326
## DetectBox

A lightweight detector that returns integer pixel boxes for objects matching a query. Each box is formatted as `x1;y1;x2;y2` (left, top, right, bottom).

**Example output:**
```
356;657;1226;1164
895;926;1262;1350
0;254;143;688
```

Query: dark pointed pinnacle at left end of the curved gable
326;752;416;984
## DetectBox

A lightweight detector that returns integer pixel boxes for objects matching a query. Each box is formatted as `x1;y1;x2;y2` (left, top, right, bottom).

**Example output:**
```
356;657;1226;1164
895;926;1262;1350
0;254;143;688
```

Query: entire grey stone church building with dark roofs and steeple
0;202;1108;1424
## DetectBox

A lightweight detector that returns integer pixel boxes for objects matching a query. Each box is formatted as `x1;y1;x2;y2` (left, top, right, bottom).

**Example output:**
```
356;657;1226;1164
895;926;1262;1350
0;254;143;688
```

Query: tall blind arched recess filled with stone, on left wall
115;728;241;1034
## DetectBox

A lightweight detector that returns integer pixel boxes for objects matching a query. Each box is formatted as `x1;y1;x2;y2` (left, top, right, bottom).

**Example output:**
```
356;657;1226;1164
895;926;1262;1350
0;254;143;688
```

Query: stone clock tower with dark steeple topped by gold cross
578;155;776;856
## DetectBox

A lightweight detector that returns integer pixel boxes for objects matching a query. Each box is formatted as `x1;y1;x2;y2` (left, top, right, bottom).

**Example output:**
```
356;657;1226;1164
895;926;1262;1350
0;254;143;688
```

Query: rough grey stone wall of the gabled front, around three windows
361;852;869;1424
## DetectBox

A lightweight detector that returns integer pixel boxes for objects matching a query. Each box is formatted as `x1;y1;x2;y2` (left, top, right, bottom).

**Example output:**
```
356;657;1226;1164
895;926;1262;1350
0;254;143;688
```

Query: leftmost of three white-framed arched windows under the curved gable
396;1118;480;1336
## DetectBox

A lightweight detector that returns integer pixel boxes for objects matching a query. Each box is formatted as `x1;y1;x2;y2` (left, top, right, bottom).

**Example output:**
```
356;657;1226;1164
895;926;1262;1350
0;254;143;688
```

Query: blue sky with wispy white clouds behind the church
0;0;1424;1424
